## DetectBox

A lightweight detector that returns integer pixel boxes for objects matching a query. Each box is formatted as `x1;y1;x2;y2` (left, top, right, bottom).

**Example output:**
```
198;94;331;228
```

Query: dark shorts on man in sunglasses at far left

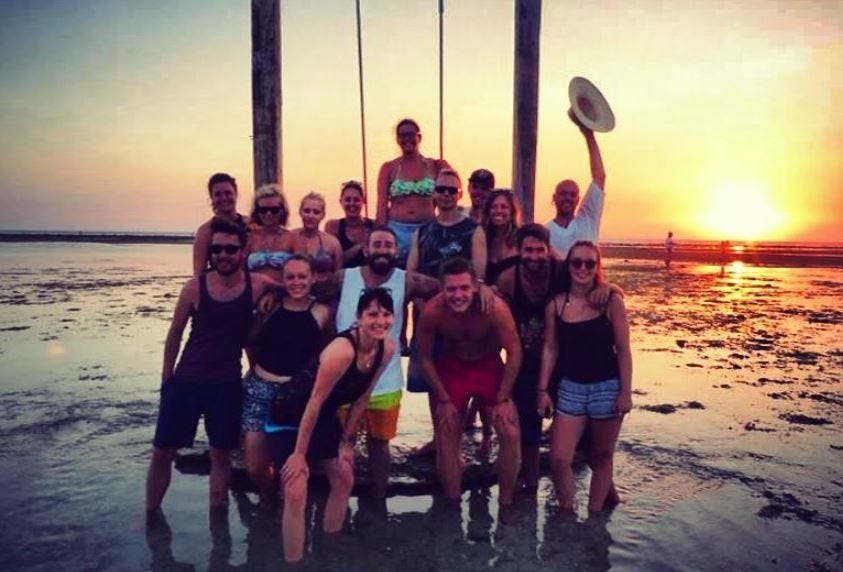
152;376;243;449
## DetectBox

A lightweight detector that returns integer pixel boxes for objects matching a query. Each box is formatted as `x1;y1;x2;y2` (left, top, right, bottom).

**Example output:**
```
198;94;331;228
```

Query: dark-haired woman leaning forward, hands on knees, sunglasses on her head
266;288;395;562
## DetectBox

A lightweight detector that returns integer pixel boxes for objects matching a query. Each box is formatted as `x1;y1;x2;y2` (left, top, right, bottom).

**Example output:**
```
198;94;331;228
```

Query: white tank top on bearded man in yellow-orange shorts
337;266;406;395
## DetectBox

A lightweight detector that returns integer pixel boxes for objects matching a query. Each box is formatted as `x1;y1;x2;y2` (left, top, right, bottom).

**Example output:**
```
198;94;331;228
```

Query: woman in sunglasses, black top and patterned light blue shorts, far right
536;241;632;512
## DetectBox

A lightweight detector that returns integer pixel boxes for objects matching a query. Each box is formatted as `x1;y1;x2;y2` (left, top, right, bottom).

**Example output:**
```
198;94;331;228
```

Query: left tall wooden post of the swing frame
252;0;284;189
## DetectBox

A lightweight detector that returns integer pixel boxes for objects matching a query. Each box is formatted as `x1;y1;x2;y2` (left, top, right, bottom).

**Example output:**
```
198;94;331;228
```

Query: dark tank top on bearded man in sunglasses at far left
175;272;252;383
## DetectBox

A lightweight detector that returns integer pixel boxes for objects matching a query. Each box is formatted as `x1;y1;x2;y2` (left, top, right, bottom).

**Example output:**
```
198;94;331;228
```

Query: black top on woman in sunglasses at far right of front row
556;296;618;383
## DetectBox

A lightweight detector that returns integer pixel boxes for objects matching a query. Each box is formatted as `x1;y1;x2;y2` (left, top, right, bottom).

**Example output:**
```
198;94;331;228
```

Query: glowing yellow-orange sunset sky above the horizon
0;0;843;241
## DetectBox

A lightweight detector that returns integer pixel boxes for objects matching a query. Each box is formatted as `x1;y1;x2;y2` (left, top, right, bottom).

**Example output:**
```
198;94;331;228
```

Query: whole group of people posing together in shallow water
146;113;632;561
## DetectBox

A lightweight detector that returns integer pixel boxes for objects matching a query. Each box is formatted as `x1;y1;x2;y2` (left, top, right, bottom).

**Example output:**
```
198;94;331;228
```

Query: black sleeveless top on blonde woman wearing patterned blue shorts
257;302;322;376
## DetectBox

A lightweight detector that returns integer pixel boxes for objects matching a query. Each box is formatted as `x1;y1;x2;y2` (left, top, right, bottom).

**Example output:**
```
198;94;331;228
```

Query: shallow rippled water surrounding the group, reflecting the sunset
0;243;843;570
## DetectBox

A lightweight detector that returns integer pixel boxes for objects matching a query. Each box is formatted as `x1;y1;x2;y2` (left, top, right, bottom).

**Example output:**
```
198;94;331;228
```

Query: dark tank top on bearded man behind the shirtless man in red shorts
510;258;557;376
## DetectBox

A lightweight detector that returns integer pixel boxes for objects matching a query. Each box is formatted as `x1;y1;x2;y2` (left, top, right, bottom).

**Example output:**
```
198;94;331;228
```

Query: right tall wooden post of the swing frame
512;0;542;222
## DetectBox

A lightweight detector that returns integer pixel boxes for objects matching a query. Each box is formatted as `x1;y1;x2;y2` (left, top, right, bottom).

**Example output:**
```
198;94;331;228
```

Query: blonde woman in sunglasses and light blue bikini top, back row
246;183;290;282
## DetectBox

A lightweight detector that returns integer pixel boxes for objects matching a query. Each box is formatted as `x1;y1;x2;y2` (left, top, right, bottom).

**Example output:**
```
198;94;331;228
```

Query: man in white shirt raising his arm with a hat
545;115;606;255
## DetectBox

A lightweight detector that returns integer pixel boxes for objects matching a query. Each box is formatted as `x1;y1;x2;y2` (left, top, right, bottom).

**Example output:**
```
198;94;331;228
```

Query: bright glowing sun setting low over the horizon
699;181;784;240
